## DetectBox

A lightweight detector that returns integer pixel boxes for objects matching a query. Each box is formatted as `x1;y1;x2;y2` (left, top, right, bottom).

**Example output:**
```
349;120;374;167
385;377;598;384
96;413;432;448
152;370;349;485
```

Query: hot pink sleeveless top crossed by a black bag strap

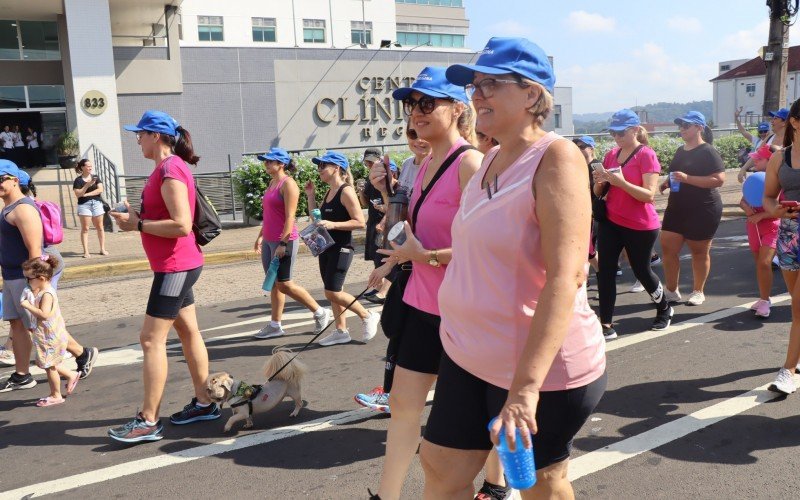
403;139;467;316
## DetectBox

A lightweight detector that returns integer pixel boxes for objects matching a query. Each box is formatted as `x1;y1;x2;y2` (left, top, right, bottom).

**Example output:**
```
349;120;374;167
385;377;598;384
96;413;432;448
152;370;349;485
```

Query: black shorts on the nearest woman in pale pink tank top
425;353;607;470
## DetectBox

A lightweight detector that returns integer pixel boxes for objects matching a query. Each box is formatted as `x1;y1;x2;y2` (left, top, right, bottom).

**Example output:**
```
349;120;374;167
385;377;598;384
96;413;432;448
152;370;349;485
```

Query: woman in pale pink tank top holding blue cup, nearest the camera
421;38;606;498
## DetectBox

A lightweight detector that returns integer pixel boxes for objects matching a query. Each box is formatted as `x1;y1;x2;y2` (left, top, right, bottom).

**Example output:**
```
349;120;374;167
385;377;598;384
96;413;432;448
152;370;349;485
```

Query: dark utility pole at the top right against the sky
762;0;790;116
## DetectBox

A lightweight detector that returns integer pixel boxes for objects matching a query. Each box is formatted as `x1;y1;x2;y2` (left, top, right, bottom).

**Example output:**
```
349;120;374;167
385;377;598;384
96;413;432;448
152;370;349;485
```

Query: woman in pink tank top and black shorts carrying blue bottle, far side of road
254;148;333;339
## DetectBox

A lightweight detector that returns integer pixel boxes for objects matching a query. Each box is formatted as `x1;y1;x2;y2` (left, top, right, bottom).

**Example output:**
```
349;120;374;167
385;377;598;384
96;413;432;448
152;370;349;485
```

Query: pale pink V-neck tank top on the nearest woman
439;132;606;391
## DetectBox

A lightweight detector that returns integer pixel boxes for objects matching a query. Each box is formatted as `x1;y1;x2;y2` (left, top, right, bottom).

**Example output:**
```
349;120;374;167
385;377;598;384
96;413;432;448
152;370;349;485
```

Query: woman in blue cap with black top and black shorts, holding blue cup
661;111;725;306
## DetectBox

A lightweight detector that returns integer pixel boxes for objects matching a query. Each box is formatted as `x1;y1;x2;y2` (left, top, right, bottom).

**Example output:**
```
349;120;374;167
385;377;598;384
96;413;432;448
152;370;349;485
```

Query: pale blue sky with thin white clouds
464;0;800;114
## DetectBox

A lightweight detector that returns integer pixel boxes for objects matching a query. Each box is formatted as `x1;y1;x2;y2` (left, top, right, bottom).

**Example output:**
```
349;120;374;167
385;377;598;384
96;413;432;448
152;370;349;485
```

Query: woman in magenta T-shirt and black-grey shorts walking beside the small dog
108;111;220;443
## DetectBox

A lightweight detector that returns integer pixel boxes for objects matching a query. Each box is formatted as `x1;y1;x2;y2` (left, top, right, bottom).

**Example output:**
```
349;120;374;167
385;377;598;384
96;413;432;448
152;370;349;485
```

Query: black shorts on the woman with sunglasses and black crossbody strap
397;306;442;375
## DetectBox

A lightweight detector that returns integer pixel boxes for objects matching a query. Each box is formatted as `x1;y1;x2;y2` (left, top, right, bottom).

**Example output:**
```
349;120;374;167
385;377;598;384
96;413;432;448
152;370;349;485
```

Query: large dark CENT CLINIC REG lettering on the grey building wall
314;76;414;140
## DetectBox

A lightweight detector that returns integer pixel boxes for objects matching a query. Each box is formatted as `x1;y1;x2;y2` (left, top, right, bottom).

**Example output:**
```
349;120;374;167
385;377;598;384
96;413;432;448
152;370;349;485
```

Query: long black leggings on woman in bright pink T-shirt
597;220;669;325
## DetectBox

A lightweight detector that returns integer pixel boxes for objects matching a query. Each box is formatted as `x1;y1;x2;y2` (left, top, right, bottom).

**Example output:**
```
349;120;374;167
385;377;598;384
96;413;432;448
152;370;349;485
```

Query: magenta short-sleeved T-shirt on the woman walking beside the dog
139;155;203;273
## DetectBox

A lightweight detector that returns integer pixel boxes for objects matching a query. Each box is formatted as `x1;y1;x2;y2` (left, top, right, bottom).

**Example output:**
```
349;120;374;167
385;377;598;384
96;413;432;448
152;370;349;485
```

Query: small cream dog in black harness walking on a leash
206;348;308;432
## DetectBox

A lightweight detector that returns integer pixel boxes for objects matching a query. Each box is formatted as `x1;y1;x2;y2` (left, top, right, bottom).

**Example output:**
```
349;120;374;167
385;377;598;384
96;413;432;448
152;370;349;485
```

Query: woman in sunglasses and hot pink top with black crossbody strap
362;66;483;499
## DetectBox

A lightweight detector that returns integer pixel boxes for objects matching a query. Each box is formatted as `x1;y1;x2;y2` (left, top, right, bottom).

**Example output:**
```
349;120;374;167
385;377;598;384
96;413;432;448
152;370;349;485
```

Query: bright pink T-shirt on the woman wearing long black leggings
603;146;661;231
